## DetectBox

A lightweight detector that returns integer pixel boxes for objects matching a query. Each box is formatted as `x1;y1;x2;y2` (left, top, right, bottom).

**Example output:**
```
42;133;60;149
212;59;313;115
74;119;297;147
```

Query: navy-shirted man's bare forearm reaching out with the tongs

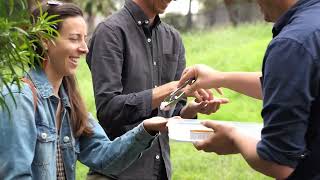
221;72;262;99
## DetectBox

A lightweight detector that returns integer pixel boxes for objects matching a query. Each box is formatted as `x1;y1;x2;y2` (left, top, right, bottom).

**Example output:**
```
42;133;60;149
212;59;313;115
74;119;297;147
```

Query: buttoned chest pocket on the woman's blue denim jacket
33;125;57;166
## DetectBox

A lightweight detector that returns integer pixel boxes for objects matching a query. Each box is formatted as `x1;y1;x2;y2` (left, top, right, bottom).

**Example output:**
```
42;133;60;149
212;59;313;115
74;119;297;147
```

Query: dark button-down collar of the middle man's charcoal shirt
124;0;161;27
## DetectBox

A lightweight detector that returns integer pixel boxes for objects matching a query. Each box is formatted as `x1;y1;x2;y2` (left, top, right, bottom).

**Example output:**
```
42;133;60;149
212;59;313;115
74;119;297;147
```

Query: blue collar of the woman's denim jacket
26;67;70;108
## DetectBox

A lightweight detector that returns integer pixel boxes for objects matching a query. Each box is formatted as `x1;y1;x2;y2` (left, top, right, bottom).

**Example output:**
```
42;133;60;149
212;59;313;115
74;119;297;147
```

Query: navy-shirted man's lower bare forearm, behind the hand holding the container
231;130;293;179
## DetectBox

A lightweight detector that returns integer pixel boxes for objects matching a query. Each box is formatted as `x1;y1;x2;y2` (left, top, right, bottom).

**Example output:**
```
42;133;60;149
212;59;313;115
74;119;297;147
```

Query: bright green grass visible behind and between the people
77;23;271;180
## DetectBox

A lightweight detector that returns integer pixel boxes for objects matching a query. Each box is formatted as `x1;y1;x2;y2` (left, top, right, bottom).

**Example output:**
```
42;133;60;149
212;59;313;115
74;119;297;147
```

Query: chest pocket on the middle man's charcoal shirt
161;54;179;84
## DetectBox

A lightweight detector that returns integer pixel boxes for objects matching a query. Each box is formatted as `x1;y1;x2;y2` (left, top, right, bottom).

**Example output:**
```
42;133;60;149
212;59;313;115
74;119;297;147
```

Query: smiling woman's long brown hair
31;3;92;137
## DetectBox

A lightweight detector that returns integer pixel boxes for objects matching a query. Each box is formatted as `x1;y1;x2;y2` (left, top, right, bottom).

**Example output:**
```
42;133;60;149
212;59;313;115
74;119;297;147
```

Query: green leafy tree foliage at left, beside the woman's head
0;0;58;114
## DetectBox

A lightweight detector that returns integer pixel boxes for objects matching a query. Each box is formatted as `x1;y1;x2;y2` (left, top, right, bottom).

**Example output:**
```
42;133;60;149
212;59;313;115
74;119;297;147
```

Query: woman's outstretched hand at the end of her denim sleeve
143;117;168;135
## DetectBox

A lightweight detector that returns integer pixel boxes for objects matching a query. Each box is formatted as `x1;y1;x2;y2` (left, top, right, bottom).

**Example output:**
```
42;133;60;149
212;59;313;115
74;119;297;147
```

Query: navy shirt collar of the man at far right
272;0;320;38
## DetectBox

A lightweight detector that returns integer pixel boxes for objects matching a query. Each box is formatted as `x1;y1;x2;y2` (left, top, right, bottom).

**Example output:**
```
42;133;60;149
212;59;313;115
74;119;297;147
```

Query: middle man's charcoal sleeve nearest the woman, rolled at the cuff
87;23;152;127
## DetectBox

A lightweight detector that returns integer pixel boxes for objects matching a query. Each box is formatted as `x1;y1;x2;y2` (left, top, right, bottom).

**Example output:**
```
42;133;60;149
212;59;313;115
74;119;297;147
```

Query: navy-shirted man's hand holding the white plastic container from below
193;121;239;155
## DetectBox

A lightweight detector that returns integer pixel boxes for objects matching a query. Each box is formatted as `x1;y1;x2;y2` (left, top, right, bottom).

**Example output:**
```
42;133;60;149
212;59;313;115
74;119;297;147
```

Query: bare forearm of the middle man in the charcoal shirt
152;81;178;109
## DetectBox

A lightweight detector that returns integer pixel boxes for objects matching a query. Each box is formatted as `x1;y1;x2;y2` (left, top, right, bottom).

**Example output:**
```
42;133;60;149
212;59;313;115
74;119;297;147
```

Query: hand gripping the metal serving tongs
178;64;223;94
